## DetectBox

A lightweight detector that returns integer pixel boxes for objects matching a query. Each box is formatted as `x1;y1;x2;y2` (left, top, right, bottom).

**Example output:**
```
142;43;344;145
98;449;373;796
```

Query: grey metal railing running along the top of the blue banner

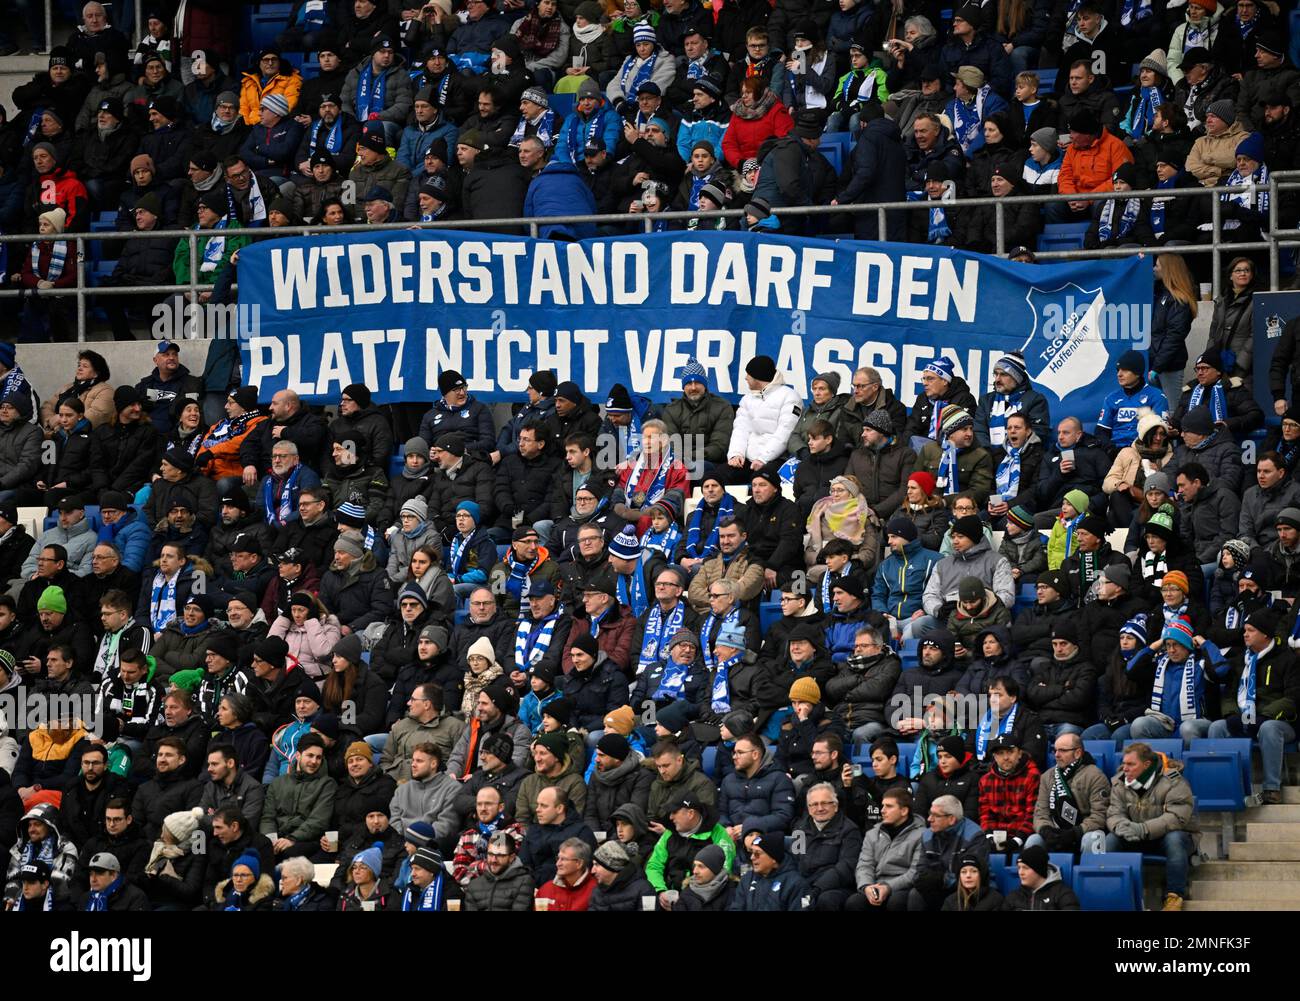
10;170;1300;342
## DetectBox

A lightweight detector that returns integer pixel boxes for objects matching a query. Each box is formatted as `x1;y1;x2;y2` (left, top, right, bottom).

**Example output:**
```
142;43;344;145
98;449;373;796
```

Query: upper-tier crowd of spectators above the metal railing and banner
0;0;1300;339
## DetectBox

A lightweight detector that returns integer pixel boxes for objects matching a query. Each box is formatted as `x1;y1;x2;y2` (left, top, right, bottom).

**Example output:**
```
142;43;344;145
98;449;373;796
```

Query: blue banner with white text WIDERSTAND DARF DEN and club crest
239;230;1152;423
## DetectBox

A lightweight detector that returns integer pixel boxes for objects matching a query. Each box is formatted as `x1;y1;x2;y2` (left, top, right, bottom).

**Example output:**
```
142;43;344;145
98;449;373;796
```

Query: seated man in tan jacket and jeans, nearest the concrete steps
1102;741;1193;910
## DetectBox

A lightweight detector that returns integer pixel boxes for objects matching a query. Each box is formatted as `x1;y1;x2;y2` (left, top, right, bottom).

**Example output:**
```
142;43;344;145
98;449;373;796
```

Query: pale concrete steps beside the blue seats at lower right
1190;785;1300;911
